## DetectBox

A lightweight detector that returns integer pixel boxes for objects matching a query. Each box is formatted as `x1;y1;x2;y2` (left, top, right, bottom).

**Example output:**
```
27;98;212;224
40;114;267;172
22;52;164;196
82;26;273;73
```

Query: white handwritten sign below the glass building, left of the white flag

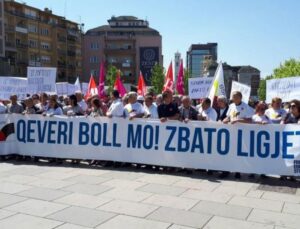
189;77;213;99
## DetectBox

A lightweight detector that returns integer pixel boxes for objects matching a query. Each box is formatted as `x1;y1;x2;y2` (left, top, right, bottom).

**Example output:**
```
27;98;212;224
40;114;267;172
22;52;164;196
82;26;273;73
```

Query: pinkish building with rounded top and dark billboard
83;16;163;85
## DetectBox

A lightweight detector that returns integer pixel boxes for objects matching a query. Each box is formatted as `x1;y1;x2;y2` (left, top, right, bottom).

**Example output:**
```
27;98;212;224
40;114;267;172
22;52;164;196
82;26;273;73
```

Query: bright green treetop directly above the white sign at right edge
273;59;300;78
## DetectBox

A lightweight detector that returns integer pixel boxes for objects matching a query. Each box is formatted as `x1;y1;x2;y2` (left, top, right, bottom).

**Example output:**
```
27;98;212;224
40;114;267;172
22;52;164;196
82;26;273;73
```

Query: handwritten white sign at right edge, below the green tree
266;76;300;103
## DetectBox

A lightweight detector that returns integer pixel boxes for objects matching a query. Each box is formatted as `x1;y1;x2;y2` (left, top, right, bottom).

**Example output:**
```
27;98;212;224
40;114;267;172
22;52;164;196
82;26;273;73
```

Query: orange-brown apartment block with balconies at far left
4;1;82;82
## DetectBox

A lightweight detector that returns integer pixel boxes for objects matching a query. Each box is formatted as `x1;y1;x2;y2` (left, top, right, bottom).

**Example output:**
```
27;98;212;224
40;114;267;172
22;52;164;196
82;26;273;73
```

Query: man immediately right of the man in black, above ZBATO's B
179;96;198;122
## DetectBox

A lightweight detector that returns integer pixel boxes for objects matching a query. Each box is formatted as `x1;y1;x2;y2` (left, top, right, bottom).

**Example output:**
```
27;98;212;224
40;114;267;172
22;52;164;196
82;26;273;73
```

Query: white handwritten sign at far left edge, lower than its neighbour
0;76;27;100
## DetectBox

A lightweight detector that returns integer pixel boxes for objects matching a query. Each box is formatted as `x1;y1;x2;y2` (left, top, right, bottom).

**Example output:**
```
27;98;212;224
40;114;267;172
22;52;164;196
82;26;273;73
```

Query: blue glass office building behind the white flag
186;43;218;77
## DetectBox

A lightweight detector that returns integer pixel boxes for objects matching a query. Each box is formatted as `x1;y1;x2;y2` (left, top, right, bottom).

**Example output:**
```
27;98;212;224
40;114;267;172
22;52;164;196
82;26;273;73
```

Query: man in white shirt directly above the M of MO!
124;92;145;119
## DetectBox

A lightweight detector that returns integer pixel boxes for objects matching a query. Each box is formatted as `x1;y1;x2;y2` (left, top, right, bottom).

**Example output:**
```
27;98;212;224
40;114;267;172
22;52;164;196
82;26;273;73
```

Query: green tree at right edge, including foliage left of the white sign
258;59;300;100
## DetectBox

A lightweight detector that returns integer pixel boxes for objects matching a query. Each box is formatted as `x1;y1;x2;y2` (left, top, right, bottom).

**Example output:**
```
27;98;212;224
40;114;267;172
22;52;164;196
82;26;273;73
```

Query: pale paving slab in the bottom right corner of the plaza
247;209;300;229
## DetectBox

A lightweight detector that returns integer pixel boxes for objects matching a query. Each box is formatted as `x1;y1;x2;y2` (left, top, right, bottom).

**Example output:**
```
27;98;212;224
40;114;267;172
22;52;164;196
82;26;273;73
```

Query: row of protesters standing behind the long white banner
0;90;300;181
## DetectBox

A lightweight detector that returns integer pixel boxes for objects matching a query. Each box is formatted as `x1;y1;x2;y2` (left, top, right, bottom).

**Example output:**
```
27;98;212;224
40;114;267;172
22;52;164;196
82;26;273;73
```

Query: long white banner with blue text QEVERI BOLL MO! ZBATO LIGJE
0;115;300;176
